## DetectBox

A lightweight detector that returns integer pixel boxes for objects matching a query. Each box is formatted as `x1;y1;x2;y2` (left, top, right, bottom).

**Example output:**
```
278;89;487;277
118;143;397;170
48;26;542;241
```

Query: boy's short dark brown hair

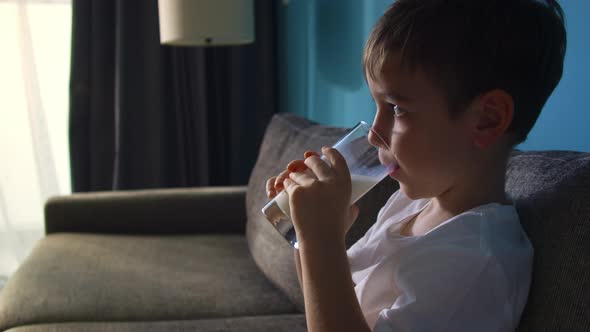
363;0;566;144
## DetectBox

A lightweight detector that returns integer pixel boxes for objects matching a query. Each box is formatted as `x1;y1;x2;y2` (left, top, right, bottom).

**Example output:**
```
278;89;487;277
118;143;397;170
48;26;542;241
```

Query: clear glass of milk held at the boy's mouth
262;121;390;248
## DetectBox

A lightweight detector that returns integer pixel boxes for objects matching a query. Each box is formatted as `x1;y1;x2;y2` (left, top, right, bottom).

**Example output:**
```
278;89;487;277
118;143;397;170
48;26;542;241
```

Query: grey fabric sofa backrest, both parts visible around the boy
246;113;590;331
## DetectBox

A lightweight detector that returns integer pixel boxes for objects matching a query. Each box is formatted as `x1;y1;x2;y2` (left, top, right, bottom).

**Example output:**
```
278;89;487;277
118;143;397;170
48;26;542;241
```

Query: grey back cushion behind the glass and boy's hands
246;113;398;312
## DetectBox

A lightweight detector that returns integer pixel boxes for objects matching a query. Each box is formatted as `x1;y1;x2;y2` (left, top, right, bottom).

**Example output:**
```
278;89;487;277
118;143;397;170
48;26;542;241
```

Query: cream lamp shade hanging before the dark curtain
158;0;254;46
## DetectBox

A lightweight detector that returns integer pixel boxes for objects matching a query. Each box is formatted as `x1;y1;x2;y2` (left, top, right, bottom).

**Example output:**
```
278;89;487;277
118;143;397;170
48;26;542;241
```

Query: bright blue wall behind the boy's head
279;0;590;152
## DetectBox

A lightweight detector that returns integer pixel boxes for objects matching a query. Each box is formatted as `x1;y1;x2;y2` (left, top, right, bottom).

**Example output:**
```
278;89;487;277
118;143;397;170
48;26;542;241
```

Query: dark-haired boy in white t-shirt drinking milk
267;0;566;331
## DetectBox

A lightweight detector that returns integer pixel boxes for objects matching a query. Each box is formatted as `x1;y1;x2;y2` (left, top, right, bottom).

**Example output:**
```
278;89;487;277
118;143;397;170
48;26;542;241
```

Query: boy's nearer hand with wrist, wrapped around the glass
284;148;358;243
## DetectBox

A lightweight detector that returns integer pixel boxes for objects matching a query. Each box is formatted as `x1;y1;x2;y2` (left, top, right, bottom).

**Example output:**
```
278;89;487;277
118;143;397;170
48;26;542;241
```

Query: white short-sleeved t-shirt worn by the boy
348;190;533;332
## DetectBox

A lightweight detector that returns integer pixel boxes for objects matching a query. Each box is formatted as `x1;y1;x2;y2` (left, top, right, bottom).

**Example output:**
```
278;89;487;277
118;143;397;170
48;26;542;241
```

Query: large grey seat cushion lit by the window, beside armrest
0;233;296;330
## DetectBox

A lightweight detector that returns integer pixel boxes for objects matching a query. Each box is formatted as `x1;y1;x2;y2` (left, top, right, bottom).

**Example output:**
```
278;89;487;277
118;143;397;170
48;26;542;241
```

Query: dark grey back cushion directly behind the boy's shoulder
506;151;590;331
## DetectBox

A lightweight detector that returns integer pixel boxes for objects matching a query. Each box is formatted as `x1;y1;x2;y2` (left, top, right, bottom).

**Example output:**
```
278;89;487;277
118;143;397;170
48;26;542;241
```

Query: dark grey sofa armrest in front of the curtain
45;186;246;234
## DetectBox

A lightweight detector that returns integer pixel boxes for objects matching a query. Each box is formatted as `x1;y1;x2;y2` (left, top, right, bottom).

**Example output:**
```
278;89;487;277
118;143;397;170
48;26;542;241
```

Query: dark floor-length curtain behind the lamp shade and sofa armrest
69;0;278;192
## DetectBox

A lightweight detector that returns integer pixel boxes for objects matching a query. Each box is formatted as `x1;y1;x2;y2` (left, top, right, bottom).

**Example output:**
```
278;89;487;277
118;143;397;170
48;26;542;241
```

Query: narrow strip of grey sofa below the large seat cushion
6;314;307;332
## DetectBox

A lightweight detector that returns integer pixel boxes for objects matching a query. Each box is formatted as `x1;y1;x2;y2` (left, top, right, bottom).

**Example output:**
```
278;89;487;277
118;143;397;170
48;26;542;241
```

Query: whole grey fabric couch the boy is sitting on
0;113;590;332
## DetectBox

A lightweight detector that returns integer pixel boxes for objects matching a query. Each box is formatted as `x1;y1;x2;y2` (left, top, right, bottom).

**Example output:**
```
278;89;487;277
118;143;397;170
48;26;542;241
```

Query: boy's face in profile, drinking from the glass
367;55;473;199
